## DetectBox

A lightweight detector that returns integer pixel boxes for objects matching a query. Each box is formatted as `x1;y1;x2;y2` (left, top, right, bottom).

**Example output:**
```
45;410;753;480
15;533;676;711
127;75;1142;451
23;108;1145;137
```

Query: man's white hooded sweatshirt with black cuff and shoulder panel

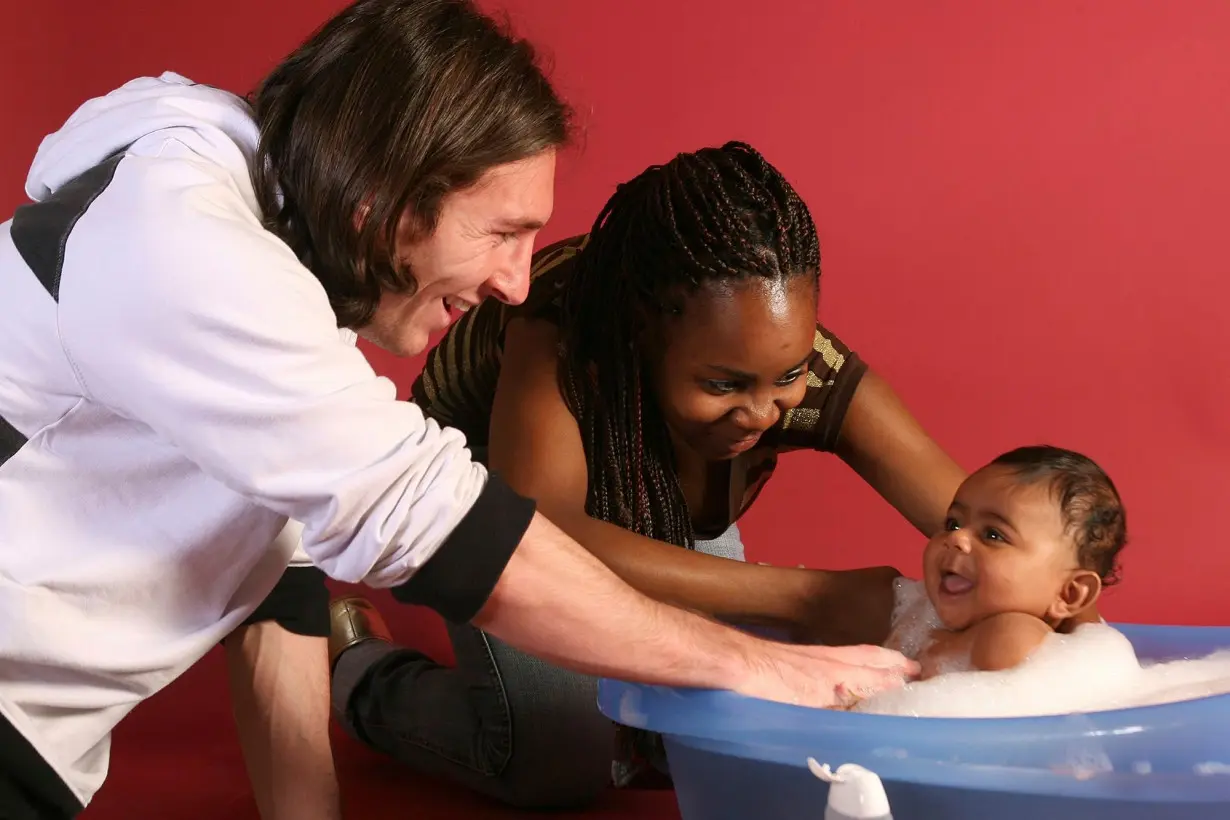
0;74;533;805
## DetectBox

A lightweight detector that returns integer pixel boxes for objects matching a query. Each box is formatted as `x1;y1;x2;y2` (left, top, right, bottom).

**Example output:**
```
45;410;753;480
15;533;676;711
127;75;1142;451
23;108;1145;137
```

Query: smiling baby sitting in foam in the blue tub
887;446;1127;680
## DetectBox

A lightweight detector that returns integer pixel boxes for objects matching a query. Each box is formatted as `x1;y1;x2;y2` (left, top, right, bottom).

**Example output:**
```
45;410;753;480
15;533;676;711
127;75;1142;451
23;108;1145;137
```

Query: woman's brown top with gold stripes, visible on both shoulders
411;235;866;518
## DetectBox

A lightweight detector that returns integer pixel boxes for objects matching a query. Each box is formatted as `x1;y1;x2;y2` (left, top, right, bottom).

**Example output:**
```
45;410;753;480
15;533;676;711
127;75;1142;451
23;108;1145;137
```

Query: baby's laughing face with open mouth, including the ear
923;465;1077;631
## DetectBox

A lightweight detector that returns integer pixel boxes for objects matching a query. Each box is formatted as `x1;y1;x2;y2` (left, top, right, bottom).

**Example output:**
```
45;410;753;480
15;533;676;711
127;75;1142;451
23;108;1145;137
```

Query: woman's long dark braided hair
560;143;820;548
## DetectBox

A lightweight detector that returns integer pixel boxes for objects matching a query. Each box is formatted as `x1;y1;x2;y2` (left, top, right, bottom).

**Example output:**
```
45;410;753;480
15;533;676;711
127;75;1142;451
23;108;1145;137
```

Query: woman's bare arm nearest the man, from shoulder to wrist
488;320;830;627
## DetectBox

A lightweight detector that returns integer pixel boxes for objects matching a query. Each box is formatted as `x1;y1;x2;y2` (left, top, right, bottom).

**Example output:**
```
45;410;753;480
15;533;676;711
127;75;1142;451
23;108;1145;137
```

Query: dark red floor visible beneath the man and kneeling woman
82;595;679;820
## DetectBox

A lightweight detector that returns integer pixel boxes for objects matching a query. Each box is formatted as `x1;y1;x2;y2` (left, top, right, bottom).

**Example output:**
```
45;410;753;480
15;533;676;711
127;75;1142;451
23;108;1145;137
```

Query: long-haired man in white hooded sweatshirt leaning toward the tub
0;0;907;818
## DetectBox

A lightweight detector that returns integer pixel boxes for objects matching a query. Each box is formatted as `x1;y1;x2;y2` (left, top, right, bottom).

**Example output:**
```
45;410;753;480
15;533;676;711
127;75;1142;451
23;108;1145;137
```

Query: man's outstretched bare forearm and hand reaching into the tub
474;508;918;707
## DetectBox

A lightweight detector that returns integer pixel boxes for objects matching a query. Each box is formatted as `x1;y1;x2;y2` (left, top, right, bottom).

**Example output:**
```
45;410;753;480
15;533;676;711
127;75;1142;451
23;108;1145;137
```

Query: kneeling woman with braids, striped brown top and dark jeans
332;143;964;806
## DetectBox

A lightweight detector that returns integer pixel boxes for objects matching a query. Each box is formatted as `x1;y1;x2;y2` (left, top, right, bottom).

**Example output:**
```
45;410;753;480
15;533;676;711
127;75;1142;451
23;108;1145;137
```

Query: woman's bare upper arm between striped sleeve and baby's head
836;370;966;537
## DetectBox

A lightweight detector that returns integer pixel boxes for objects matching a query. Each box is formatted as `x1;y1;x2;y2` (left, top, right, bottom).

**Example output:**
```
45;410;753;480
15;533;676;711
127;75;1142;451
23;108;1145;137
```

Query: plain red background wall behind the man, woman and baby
0;0;1230;623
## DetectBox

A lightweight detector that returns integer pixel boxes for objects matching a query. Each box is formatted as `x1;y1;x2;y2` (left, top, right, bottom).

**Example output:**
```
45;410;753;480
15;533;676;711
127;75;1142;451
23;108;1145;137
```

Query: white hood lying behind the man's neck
26;71;260;202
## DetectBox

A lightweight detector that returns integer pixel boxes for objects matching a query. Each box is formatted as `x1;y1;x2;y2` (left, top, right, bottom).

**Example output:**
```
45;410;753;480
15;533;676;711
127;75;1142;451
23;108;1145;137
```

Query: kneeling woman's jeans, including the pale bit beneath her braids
333;526;743;809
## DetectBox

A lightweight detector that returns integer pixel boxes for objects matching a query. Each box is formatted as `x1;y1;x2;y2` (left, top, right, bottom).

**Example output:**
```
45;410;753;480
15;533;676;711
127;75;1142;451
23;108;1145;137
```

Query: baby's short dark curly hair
991;445;1128;586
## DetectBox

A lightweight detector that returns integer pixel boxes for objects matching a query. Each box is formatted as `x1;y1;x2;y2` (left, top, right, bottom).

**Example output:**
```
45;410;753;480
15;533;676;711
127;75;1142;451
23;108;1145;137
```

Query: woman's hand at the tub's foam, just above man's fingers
791;567;900;647
